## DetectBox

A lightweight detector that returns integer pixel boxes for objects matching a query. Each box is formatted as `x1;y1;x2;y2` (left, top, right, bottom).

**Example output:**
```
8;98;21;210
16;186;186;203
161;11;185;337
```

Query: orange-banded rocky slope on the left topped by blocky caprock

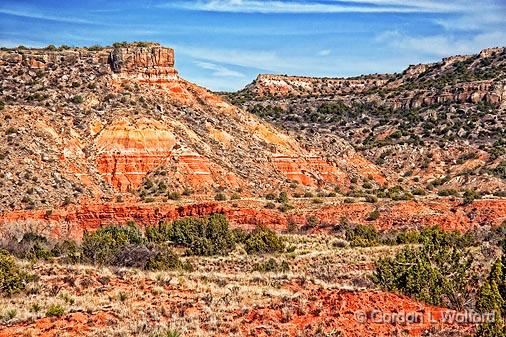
0;43;384;212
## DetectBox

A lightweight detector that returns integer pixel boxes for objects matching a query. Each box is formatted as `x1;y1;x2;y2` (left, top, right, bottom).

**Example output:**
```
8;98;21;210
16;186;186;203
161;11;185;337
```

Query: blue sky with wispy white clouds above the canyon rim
0;0;506;91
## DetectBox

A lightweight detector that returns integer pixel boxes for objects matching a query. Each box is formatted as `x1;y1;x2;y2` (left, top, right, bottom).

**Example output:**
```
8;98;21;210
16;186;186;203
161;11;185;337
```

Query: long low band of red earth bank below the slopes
0;199;506;239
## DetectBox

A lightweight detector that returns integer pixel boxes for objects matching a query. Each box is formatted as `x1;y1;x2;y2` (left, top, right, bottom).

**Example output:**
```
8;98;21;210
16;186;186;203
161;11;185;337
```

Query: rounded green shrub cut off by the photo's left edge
0;250;30;296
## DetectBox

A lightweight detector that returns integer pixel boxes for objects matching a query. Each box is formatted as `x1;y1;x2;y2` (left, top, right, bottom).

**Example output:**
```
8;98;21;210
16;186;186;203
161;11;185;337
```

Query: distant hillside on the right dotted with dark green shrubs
226;47;506;195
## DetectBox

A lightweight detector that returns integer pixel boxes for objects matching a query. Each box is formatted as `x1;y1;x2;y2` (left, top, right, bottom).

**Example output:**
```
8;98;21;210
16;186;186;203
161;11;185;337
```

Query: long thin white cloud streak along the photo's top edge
160;0;462;14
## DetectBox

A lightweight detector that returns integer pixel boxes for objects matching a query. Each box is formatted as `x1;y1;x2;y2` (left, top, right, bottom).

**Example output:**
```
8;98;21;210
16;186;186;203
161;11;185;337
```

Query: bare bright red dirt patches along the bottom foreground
0;282;474;337
